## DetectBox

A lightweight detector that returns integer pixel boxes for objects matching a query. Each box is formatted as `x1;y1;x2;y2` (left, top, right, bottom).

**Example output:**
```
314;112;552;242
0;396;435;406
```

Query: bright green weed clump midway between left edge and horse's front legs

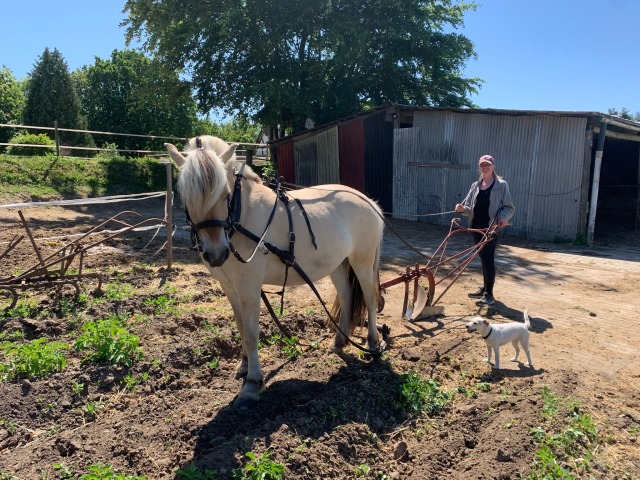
74;317;142;367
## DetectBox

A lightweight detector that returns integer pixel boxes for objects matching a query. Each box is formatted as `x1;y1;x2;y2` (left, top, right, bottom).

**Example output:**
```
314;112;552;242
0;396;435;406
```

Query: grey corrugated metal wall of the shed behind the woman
393;111;588;240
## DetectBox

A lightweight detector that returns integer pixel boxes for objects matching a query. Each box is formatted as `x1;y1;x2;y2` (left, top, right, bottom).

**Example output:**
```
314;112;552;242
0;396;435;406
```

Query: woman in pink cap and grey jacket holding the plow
455;155;515;305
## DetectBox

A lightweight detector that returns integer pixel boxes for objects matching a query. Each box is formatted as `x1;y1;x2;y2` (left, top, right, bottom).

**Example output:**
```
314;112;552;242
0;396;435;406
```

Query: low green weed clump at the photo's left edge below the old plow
0;338;69;380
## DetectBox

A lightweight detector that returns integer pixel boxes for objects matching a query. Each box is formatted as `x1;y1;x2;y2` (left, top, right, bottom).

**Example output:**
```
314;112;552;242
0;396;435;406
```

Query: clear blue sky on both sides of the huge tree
0;0;640;114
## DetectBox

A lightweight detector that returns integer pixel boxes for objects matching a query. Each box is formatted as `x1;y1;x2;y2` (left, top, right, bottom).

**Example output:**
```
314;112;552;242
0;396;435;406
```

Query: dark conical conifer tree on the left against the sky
24;48;92;145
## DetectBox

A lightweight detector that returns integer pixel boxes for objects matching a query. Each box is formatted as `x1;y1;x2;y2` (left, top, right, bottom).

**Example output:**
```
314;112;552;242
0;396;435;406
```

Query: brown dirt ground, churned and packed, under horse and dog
0;197;640;480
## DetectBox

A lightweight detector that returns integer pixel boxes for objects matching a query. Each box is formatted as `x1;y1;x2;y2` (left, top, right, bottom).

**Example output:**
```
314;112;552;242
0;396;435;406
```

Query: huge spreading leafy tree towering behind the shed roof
124;0;480;136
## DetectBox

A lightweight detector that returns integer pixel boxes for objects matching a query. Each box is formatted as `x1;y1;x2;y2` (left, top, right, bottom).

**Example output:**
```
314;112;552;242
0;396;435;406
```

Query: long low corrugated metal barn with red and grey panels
270;105;640;243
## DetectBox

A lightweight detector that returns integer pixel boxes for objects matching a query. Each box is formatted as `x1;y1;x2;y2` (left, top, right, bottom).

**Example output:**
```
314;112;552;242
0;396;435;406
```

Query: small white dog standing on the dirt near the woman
465;310;533;369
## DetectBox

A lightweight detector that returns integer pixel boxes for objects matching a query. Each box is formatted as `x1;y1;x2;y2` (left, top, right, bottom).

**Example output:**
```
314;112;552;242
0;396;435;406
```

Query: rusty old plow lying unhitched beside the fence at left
0;211;167;311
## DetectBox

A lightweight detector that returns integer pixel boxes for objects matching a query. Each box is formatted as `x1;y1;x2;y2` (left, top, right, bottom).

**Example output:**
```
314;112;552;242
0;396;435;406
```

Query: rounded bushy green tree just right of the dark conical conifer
80;50;196;150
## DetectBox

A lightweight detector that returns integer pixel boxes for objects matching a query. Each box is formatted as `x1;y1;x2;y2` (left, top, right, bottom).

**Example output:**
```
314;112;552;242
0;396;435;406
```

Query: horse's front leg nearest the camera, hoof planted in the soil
233;287;264;408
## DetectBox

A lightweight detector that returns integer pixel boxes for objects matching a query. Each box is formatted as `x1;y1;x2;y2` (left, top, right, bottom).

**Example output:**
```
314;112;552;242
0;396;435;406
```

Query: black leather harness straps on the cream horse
185;156;389;355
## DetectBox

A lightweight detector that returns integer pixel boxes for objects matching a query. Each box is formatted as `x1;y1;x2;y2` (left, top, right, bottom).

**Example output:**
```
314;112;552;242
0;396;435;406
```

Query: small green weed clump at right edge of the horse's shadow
397;372;451;415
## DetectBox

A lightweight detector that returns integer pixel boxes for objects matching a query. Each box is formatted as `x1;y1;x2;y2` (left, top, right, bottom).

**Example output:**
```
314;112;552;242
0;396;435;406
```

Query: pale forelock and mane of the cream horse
178;135;262;216
